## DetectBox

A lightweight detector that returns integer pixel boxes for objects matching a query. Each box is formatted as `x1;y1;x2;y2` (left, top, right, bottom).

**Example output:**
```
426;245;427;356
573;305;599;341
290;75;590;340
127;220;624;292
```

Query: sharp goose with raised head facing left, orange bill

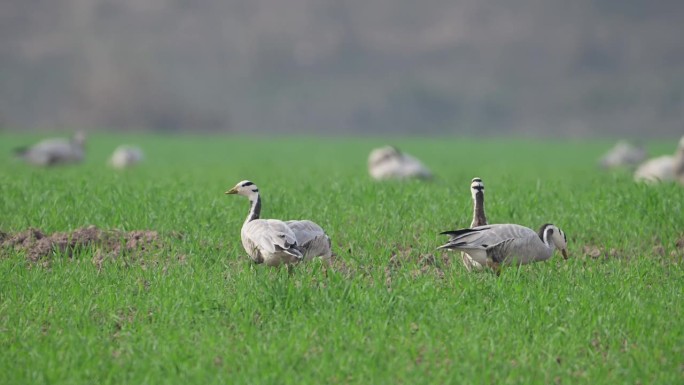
226;180;304;266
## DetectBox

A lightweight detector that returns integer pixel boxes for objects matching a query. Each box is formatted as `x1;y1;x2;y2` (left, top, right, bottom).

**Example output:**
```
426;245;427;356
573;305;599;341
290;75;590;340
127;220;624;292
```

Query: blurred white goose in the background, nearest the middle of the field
368;146;432;180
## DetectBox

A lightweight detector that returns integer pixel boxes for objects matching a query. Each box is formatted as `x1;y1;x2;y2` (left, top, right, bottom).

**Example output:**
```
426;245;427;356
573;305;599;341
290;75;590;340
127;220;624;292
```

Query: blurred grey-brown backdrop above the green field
0;0;684;136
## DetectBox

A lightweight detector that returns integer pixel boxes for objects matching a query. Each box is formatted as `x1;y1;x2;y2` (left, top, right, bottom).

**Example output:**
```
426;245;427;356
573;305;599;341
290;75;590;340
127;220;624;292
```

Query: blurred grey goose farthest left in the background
14;131;86;166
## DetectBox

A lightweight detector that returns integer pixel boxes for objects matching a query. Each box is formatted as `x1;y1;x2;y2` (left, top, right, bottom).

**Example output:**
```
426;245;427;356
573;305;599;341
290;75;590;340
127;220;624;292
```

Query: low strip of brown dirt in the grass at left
0;226;161;264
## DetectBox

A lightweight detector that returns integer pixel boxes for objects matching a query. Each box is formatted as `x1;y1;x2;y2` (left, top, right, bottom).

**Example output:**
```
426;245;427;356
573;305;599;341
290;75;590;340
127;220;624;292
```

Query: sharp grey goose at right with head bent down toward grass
438;223;568;268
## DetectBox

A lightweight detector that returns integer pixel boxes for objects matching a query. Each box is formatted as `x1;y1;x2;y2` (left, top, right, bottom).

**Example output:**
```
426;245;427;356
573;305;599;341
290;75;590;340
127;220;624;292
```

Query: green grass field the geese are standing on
0;134;684;384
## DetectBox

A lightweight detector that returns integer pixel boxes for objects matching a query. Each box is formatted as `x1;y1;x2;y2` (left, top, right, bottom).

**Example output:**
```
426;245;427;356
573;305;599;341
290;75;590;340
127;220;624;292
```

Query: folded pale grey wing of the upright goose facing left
242;219;302;258
